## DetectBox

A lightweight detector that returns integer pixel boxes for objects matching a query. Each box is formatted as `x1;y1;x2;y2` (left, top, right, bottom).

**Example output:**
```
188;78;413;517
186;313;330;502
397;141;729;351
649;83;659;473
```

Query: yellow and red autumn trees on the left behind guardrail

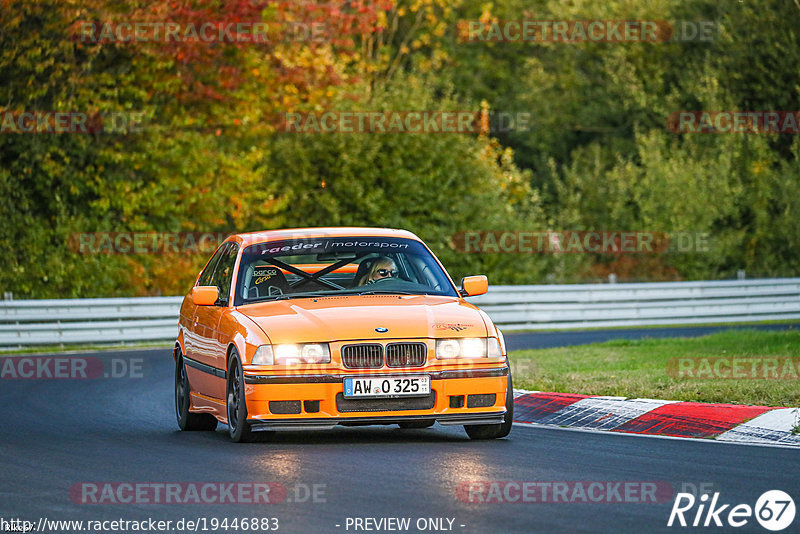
0;0;390;297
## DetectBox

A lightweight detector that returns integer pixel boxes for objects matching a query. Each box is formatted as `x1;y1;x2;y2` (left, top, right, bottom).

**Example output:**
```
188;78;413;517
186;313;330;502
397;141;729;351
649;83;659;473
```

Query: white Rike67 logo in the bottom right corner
667;490;795;532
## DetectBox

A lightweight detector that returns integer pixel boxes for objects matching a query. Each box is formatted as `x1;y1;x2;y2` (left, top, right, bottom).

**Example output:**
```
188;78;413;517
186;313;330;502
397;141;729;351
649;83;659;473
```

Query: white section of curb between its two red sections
535;397;678;430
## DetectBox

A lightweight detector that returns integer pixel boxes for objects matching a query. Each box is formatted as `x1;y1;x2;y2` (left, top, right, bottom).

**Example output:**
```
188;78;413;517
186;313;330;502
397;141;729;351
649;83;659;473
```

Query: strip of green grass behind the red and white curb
509;330;800;406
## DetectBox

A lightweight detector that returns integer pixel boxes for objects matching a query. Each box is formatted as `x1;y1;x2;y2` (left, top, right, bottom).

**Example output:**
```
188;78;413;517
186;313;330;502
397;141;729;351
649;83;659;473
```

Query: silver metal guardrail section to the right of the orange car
469;278;800;331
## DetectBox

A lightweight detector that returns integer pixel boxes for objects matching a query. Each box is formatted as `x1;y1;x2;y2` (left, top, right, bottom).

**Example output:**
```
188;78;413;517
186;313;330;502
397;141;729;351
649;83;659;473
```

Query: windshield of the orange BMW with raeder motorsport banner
235;237;457;306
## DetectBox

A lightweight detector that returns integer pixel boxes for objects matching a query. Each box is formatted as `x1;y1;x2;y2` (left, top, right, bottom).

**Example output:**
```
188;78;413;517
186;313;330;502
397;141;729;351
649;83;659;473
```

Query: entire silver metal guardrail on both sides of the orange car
0;278;800;347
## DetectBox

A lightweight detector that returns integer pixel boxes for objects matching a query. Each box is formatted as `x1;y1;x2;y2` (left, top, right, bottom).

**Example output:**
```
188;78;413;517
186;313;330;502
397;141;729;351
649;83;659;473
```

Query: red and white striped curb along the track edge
514;389;800;447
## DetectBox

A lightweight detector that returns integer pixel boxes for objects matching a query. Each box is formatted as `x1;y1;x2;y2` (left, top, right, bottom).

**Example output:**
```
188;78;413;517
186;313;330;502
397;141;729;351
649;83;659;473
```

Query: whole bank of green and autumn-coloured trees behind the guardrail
0;0;800;297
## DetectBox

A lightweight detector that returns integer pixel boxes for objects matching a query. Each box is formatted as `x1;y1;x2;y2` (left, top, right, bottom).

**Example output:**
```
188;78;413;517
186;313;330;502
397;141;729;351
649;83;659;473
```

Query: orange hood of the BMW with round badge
238;295;487;344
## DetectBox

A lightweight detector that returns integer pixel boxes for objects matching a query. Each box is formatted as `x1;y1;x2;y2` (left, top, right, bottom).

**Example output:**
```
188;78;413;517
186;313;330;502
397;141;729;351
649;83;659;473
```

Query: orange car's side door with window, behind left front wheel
194;243;239;399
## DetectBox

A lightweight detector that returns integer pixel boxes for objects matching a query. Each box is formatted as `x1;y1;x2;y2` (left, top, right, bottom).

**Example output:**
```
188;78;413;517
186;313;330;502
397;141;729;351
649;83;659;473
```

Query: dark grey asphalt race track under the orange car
0;324;800;533
